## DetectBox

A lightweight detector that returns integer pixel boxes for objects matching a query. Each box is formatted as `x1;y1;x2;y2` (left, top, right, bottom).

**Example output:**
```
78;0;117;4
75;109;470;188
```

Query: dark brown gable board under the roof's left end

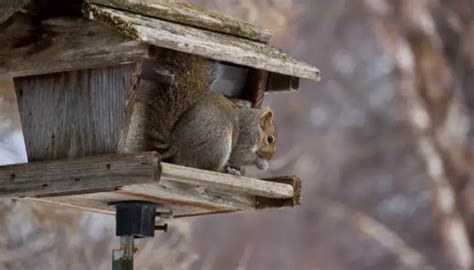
0;16;148;77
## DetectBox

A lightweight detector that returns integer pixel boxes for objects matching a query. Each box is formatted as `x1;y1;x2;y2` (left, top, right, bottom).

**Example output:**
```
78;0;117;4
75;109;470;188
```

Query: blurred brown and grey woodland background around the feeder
0;0;474;270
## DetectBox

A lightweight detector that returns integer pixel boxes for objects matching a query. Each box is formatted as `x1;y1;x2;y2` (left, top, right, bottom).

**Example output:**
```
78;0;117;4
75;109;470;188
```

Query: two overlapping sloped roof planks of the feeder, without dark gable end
83;0;320;81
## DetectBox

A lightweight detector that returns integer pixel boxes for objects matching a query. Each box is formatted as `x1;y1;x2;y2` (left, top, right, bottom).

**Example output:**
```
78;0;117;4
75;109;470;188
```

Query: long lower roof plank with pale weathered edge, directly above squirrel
84;4;320;80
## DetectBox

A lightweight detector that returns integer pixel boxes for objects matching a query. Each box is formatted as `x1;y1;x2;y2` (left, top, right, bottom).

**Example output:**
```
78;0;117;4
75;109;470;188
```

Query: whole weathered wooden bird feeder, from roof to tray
0;0;319;221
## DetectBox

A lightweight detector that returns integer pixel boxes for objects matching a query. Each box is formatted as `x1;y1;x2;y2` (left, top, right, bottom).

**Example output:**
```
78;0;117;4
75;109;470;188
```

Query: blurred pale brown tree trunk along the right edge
366;0;474;269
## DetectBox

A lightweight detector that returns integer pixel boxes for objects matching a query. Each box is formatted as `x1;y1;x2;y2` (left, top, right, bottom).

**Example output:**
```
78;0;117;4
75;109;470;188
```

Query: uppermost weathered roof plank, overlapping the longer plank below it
86;0;271;42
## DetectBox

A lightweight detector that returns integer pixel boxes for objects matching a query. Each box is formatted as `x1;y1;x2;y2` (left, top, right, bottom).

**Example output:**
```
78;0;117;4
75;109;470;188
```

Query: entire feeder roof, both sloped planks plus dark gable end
0;0;320;81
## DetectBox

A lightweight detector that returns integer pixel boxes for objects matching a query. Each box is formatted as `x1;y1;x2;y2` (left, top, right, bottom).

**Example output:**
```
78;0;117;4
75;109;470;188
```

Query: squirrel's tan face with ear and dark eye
257;108;277;160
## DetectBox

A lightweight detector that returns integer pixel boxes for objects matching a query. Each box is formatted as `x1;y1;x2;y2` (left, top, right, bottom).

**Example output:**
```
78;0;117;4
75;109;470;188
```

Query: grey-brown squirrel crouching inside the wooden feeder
131;49;277;175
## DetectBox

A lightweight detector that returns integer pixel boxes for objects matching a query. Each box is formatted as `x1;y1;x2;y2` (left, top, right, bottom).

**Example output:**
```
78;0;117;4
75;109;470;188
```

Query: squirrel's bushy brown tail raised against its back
131;49;215;157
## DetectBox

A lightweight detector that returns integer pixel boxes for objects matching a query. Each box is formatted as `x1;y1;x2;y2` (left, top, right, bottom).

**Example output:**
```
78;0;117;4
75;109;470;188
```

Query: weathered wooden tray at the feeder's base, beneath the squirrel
0;152;301;217
